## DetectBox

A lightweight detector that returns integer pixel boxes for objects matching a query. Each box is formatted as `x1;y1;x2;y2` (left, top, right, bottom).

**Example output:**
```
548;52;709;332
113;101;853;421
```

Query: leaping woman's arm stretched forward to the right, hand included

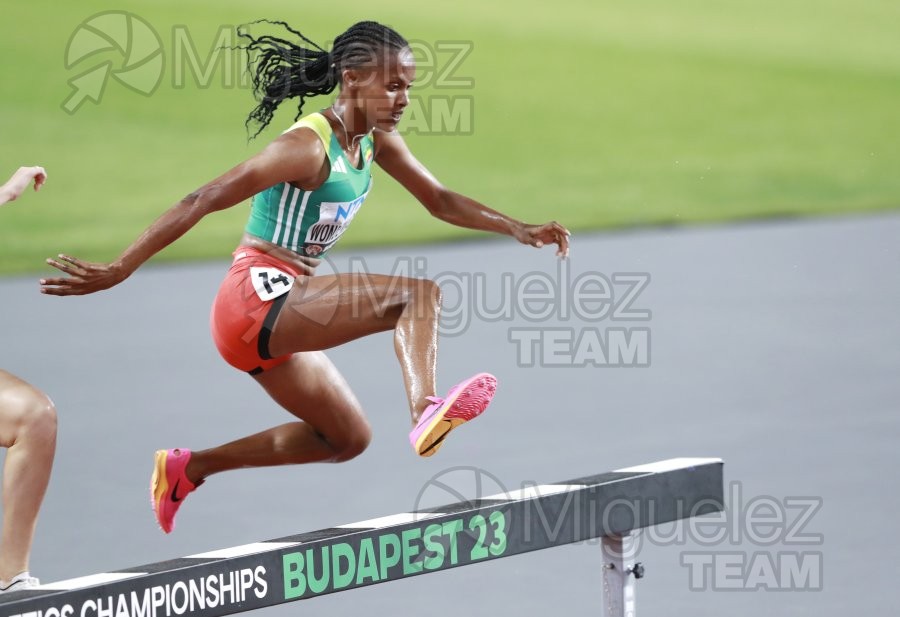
375;131;569;257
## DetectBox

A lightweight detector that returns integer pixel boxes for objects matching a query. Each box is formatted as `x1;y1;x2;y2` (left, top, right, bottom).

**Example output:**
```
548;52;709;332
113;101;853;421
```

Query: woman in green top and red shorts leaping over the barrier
41;22;569;533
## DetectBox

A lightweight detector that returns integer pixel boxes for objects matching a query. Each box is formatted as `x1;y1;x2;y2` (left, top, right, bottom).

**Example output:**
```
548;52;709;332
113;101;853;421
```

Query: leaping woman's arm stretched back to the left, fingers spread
41;130;328;296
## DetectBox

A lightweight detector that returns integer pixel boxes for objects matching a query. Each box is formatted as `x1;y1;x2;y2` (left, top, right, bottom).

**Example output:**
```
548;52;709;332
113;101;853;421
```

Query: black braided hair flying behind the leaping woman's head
238;20;409;139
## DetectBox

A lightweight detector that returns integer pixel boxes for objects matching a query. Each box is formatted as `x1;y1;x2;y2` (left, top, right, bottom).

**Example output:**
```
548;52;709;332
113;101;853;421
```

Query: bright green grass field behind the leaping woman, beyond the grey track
0;0;900;273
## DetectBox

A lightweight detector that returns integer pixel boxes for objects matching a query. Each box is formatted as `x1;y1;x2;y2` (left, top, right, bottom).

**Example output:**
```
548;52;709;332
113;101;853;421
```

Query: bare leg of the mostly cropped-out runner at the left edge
0;370;56;581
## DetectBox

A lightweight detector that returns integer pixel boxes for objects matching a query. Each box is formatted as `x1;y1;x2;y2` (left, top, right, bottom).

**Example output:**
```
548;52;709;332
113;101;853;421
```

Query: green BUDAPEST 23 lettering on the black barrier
282;511;509;600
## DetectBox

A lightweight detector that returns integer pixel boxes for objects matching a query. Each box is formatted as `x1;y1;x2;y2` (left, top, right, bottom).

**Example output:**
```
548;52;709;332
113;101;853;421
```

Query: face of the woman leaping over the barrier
350;48;416;132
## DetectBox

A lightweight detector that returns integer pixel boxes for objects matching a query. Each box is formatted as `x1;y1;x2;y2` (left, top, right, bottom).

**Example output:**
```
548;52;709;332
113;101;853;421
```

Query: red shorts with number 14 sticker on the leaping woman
210;246;300;375
